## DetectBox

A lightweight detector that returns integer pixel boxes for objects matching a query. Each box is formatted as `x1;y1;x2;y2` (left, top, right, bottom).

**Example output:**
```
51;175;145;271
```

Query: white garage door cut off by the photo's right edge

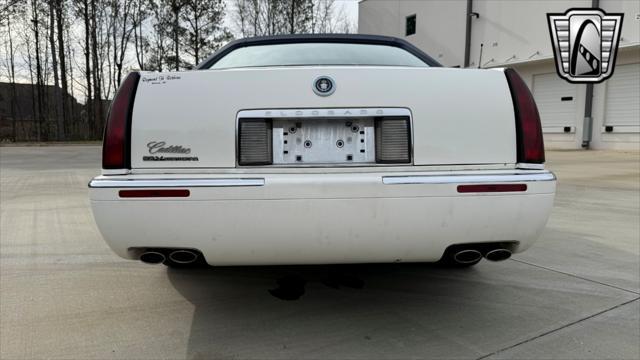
604;63;640;127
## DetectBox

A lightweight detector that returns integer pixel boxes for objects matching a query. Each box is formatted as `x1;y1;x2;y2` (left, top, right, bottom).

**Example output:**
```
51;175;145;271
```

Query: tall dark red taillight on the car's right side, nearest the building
504;69;544;164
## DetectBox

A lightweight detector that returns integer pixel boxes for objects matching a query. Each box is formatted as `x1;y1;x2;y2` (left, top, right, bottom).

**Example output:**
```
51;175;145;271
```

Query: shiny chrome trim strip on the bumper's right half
382;171;556;185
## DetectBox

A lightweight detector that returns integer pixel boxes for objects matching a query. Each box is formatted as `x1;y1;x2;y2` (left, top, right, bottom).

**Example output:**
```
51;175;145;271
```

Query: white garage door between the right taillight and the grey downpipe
533;69;576;132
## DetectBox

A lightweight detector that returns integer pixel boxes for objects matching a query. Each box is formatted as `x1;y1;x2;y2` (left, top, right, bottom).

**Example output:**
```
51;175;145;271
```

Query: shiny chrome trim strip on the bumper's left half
89;177;264;188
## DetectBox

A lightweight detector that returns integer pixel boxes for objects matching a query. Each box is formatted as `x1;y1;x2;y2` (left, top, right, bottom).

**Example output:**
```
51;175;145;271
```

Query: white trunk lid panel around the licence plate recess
131;66;516;169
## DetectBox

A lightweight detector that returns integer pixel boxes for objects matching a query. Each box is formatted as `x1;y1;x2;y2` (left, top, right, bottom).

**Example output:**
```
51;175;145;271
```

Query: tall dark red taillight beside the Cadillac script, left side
102;72;140;169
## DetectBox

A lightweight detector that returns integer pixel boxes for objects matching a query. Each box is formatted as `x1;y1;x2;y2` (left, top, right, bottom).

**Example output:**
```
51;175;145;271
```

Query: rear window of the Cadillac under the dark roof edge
209;43;429;69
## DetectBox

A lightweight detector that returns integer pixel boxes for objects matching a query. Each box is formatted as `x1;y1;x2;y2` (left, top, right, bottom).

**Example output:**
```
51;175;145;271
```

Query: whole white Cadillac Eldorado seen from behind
89;35;556;267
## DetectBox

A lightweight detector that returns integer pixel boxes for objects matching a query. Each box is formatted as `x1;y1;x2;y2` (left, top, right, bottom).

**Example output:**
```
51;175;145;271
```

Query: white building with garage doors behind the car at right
358;0;640;149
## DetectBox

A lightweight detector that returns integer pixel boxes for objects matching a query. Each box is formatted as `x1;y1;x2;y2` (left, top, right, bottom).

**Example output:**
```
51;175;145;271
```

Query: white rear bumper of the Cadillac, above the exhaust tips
91;170;555;265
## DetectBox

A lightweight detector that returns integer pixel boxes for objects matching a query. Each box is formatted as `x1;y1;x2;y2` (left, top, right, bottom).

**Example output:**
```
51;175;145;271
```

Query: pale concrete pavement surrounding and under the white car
0;146;640;359
